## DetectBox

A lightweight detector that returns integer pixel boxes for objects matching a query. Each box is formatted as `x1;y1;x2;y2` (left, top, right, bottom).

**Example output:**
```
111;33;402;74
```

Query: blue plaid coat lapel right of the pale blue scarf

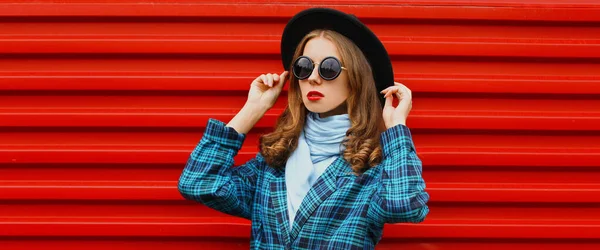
286;157;351;241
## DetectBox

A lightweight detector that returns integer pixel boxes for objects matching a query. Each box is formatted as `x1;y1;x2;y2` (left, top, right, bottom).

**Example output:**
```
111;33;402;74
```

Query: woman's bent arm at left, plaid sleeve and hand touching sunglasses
178;72;287;219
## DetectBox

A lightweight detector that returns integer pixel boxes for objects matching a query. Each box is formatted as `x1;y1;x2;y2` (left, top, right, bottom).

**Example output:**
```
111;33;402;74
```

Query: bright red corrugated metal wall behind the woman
0;0;600;250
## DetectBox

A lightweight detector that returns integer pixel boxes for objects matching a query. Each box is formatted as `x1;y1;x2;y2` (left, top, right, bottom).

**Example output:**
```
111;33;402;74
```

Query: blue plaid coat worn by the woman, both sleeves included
179;119;429;250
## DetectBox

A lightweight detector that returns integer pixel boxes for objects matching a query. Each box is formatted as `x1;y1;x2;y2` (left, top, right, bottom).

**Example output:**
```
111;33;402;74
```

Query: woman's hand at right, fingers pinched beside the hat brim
381;82;412;128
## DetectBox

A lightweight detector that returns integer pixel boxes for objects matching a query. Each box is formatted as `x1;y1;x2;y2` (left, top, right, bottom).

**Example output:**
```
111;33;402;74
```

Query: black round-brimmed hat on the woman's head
281;8;394;105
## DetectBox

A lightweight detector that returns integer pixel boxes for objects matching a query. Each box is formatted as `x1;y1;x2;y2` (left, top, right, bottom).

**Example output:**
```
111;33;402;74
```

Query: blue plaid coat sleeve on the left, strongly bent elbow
178;119;264;219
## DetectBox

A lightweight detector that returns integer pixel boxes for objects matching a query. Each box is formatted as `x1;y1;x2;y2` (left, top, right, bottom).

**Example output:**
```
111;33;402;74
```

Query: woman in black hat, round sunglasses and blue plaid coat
179;8;429;249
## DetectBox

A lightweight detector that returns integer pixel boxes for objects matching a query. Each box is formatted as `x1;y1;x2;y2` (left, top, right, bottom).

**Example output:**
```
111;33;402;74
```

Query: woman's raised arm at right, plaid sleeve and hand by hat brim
372;83;429;223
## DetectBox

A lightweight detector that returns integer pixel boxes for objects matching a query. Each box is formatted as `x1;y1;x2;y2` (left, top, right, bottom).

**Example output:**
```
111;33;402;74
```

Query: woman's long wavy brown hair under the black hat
260;30;385;174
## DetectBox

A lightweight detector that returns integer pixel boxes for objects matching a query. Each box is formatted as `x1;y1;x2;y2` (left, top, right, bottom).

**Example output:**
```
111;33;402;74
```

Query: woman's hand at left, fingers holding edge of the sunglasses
246;71;288;112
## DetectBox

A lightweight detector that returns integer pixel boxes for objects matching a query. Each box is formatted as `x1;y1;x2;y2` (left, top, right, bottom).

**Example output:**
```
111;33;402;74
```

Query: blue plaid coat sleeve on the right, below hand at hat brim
371;124;429;223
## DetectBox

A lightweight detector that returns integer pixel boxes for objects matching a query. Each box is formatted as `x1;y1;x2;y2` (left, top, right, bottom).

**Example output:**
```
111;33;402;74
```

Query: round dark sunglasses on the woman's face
292;56;346;81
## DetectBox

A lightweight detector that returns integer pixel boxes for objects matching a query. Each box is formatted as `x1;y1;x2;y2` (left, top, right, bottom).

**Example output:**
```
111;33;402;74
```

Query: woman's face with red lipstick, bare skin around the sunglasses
299;37;350;117
